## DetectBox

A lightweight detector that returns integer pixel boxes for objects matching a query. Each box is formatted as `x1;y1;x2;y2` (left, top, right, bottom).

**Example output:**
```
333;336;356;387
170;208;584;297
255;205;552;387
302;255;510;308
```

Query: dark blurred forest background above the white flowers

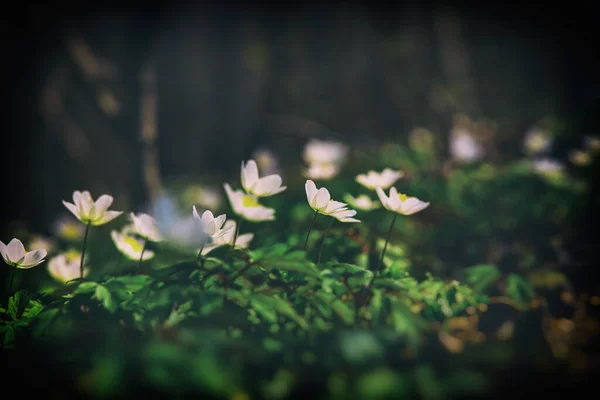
1;2;600;234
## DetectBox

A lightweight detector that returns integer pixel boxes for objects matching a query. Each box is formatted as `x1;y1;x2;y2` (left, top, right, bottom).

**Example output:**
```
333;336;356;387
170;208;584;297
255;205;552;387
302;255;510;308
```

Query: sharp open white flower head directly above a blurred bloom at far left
63;190;123;226
